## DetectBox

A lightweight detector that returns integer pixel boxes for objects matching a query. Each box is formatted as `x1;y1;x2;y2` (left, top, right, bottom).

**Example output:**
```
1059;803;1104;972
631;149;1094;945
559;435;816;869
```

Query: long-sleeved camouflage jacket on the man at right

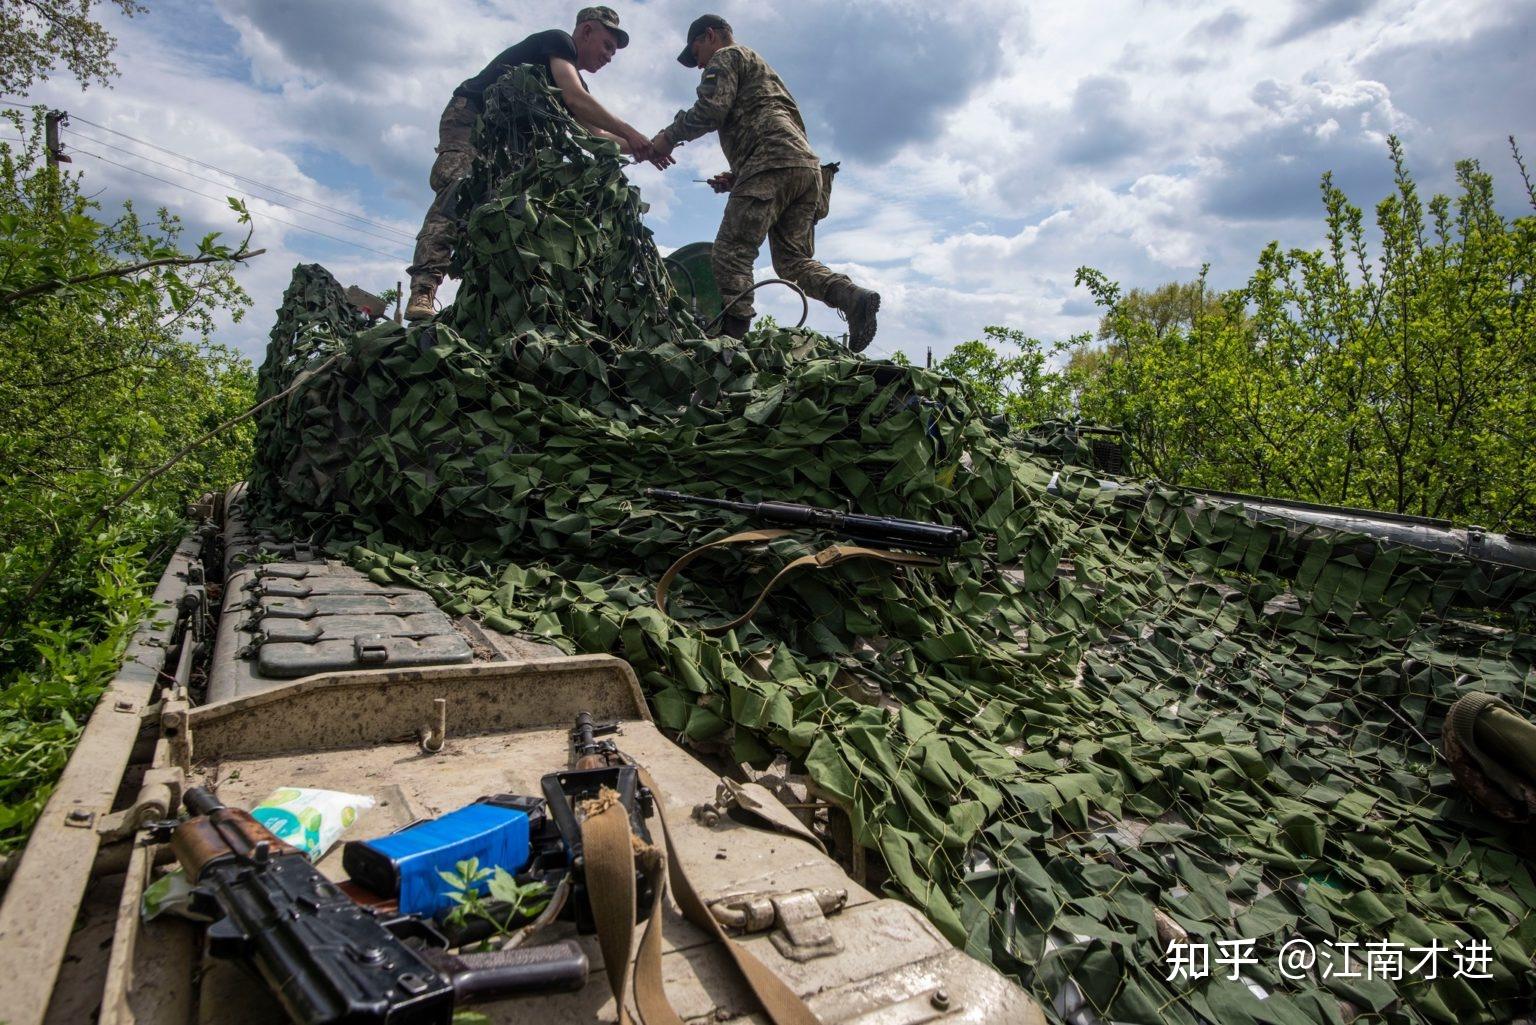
667;45;822;187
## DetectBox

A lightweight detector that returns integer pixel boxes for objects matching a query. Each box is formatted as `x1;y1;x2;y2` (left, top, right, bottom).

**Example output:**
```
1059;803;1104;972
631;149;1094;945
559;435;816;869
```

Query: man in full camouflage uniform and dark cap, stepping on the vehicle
651;14;880;352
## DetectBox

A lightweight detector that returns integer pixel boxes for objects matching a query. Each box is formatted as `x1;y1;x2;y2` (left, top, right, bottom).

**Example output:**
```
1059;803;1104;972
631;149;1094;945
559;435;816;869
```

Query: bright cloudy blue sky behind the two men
3;0;1536;363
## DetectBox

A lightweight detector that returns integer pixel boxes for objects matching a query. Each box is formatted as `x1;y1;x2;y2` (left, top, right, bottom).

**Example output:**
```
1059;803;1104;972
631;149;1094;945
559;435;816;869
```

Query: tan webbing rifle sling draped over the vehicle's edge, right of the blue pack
582;768;822;1025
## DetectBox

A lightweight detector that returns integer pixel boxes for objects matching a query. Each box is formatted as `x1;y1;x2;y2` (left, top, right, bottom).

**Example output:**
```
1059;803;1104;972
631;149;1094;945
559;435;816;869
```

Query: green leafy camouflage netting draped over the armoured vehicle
252;72;1536;1025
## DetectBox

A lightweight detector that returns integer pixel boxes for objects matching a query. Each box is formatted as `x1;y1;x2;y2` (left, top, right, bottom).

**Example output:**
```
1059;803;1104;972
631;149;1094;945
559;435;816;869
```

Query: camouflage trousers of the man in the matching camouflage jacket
710;168;852;318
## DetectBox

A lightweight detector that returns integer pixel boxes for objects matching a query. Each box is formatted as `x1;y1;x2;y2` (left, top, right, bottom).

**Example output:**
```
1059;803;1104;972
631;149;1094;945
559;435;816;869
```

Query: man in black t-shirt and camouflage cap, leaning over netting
406;8;671;320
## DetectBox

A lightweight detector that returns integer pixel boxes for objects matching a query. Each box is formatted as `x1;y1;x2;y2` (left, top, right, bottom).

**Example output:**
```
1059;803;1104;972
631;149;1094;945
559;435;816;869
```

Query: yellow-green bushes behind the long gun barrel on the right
1069;140;1536;530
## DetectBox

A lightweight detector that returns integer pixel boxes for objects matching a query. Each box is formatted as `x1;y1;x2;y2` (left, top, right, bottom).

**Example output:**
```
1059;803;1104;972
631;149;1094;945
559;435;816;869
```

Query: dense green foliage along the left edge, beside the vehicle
0;112;255;848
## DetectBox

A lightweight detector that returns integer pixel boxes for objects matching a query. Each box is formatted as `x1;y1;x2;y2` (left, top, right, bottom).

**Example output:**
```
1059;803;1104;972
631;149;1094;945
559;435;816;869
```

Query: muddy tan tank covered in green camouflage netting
0;62;1536;1025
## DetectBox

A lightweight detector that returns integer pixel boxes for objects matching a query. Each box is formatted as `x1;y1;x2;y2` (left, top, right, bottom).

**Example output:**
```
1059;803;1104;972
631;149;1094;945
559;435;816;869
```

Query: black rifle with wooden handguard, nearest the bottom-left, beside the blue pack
155;787;587;1025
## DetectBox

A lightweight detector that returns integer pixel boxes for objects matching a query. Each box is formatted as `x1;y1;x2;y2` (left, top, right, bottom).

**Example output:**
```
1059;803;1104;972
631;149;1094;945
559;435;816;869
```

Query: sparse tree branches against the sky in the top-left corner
0;0;147;94
